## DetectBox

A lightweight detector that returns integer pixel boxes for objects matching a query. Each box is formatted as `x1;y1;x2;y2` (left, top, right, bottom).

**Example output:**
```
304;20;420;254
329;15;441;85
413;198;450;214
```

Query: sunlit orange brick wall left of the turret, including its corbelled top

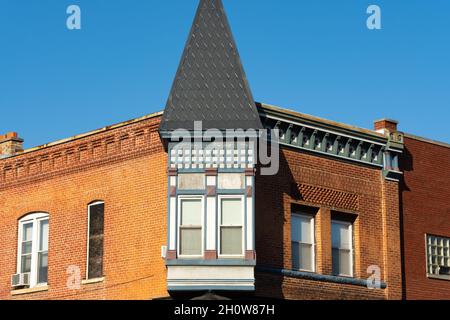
0;118;167;299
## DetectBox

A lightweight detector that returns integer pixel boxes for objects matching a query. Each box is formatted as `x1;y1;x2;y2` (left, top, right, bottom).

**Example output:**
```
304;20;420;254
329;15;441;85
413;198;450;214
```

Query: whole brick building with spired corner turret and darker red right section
0;0;450;299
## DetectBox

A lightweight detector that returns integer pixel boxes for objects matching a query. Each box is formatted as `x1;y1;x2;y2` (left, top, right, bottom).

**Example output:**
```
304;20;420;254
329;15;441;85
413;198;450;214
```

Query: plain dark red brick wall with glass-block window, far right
401;137;450;299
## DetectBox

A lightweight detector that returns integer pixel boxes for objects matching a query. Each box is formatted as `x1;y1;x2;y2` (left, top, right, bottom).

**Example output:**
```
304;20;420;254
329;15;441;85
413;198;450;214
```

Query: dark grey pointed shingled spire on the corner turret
160;0;262;132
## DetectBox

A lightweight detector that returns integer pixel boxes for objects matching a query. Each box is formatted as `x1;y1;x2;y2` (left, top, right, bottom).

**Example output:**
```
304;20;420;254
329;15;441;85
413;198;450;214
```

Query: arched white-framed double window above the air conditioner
17;213;49;287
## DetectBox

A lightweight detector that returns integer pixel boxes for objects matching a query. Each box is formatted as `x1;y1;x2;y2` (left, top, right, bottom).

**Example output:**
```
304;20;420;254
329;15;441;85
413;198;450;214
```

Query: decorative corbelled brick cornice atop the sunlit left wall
0;117;164;189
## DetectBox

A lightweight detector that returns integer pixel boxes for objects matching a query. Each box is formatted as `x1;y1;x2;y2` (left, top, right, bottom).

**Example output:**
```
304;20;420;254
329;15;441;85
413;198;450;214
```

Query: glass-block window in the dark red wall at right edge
427;235;450;279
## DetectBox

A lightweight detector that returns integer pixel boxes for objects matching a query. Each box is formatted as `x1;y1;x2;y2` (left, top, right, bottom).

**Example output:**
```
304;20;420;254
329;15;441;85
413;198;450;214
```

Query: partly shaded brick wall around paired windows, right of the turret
256;148;401;299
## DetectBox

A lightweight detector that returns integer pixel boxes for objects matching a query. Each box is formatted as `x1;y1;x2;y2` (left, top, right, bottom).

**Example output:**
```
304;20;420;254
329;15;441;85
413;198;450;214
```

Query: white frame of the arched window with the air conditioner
16;212;50;288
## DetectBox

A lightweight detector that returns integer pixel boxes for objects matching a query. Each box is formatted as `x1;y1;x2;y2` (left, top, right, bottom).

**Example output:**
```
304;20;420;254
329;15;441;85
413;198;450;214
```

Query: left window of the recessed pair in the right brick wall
291;214;315;272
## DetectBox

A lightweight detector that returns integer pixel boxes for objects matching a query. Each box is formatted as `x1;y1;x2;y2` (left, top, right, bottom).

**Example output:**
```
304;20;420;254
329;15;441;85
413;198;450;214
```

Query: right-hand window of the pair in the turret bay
219;196;244;256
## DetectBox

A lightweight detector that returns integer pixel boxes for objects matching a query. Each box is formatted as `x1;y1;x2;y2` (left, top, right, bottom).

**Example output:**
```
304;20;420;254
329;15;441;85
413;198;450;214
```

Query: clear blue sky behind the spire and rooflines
0;0;450;147
